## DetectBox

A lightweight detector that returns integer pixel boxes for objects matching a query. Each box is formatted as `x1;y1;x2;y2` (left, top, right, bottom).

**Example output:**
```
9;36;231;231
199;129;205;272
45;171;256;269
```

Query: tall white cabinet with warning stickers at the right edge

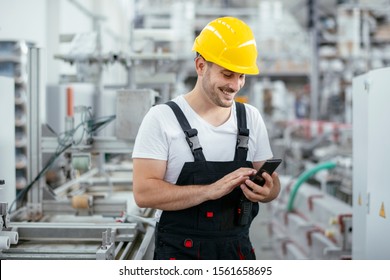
353;68;390;259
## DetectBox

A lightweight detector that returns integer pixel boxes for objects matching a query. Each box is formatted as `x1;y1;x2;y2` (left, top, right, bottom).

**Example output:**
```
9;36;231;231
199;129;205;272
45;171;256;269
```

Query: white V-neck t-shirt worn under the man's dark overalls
132;95;272;184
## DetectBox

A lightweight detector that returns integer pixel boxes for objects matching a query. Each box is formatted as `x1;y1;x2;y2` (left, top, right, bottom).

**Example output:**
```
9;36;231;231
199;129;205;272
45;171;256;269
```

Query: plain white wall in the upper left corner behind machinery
0;0;134;84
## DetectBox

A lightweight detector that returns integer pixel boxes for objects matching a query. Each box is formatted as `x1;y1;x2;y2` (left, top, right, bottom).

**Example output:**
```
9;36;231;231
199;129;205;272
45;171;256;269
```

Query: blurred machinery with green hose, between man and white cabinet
265;106;353;260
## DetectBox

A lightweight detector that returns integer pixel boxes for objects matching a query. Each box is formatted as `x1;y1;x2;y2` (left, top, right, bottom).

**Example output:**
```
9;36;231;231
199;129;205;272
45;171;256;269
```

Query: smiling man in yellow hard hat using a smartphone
133;17;280;259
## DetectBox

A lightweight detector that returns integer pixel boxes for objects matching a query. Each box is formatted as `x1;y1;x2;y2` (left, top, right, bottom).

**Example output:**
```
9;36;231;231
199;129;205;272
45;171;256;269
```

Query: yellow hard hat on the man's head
192;17;259;75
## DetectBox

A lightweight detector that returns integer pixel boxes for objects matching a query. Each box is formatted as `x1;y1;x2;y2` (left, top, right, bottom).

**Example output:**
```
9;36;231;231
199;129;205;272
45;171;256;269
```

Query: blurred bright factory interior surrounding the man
0;0;390;260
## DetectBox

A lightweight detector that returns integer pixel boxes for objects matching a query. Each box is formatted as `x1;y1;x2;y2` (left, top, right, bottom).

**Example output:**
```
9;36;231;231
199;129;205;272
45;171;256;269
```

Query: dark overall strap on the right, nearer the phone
234;102;249;161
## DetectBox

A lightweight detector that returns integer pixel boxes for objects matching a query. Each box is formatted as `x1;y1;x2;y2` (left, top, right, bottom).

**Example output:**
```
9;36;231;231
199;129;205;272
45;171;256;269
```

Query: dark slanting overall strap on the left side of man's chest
165;101;206;161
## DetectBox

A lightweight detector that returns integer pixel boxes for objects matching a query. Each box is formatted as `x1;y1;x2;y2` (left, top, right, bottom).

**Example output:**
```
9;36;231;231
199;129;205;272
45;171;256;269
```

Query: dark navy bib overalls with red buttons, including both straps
154;101;259;260
